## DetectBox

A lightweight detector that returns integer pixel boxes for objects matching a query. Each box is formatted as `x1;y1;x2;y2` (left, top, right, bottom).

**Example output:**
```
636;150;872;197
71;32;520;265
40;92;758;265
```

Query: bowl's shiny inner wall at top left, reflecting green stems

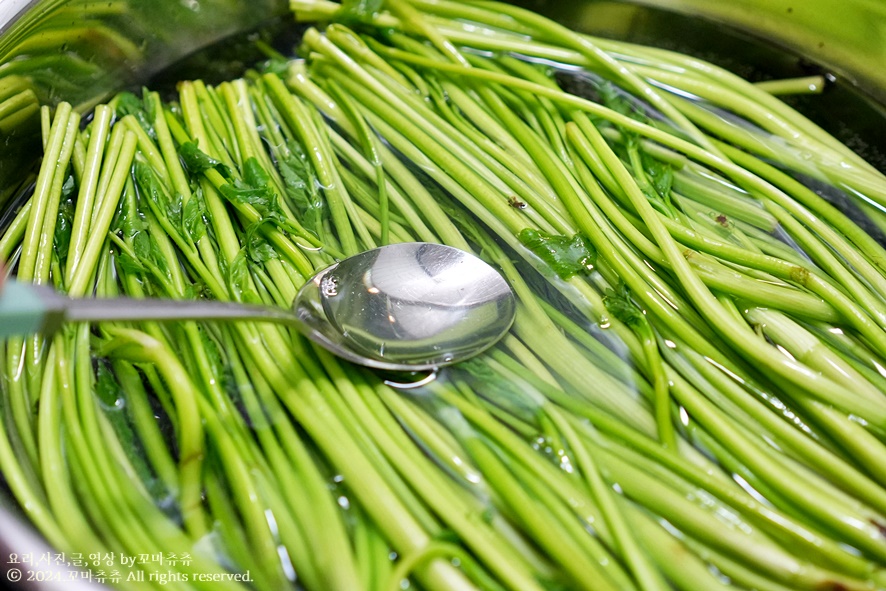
0;0;291;206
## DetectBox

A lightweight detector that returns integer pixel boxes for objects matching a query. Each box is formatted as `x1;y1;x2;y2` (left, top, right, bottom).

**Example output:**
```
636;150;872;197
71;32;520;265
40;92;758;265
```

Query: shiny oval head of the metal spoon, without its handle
306;243;516;369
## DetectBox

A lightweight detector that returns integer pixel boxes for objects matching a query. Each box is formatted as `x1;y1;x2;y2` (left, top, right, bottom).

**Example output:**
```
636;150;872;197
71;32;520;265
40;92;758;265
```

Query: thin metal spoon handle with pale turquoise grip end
0;280;297;337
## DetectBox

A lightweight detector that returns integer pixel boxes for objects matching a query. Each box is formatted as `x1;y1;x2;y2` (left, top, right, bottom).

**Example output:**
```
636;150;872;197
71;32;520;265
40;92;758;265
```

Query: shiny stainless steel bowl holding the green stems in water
0;0;886;589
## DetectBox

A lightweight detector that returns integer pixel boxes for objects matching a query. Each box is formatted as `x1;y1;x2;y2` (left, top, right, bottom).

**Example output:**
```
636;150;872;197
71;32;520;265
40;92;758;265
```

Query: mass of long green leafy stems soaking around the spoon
0;0;886;591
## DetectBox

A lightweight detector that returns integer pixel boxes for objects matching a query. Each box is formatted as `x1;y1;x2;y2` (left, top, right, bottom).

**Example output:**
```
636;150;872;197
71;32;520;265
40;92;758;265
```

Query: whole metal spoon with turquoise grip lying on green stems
0;242;516;371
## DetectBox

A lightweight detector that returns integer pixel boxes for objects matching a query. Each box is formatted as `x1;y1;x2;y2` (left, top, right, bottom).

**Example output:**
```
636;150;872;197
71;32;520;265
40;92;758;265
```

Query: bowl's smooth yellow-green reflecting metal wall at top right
512;0;886;103
